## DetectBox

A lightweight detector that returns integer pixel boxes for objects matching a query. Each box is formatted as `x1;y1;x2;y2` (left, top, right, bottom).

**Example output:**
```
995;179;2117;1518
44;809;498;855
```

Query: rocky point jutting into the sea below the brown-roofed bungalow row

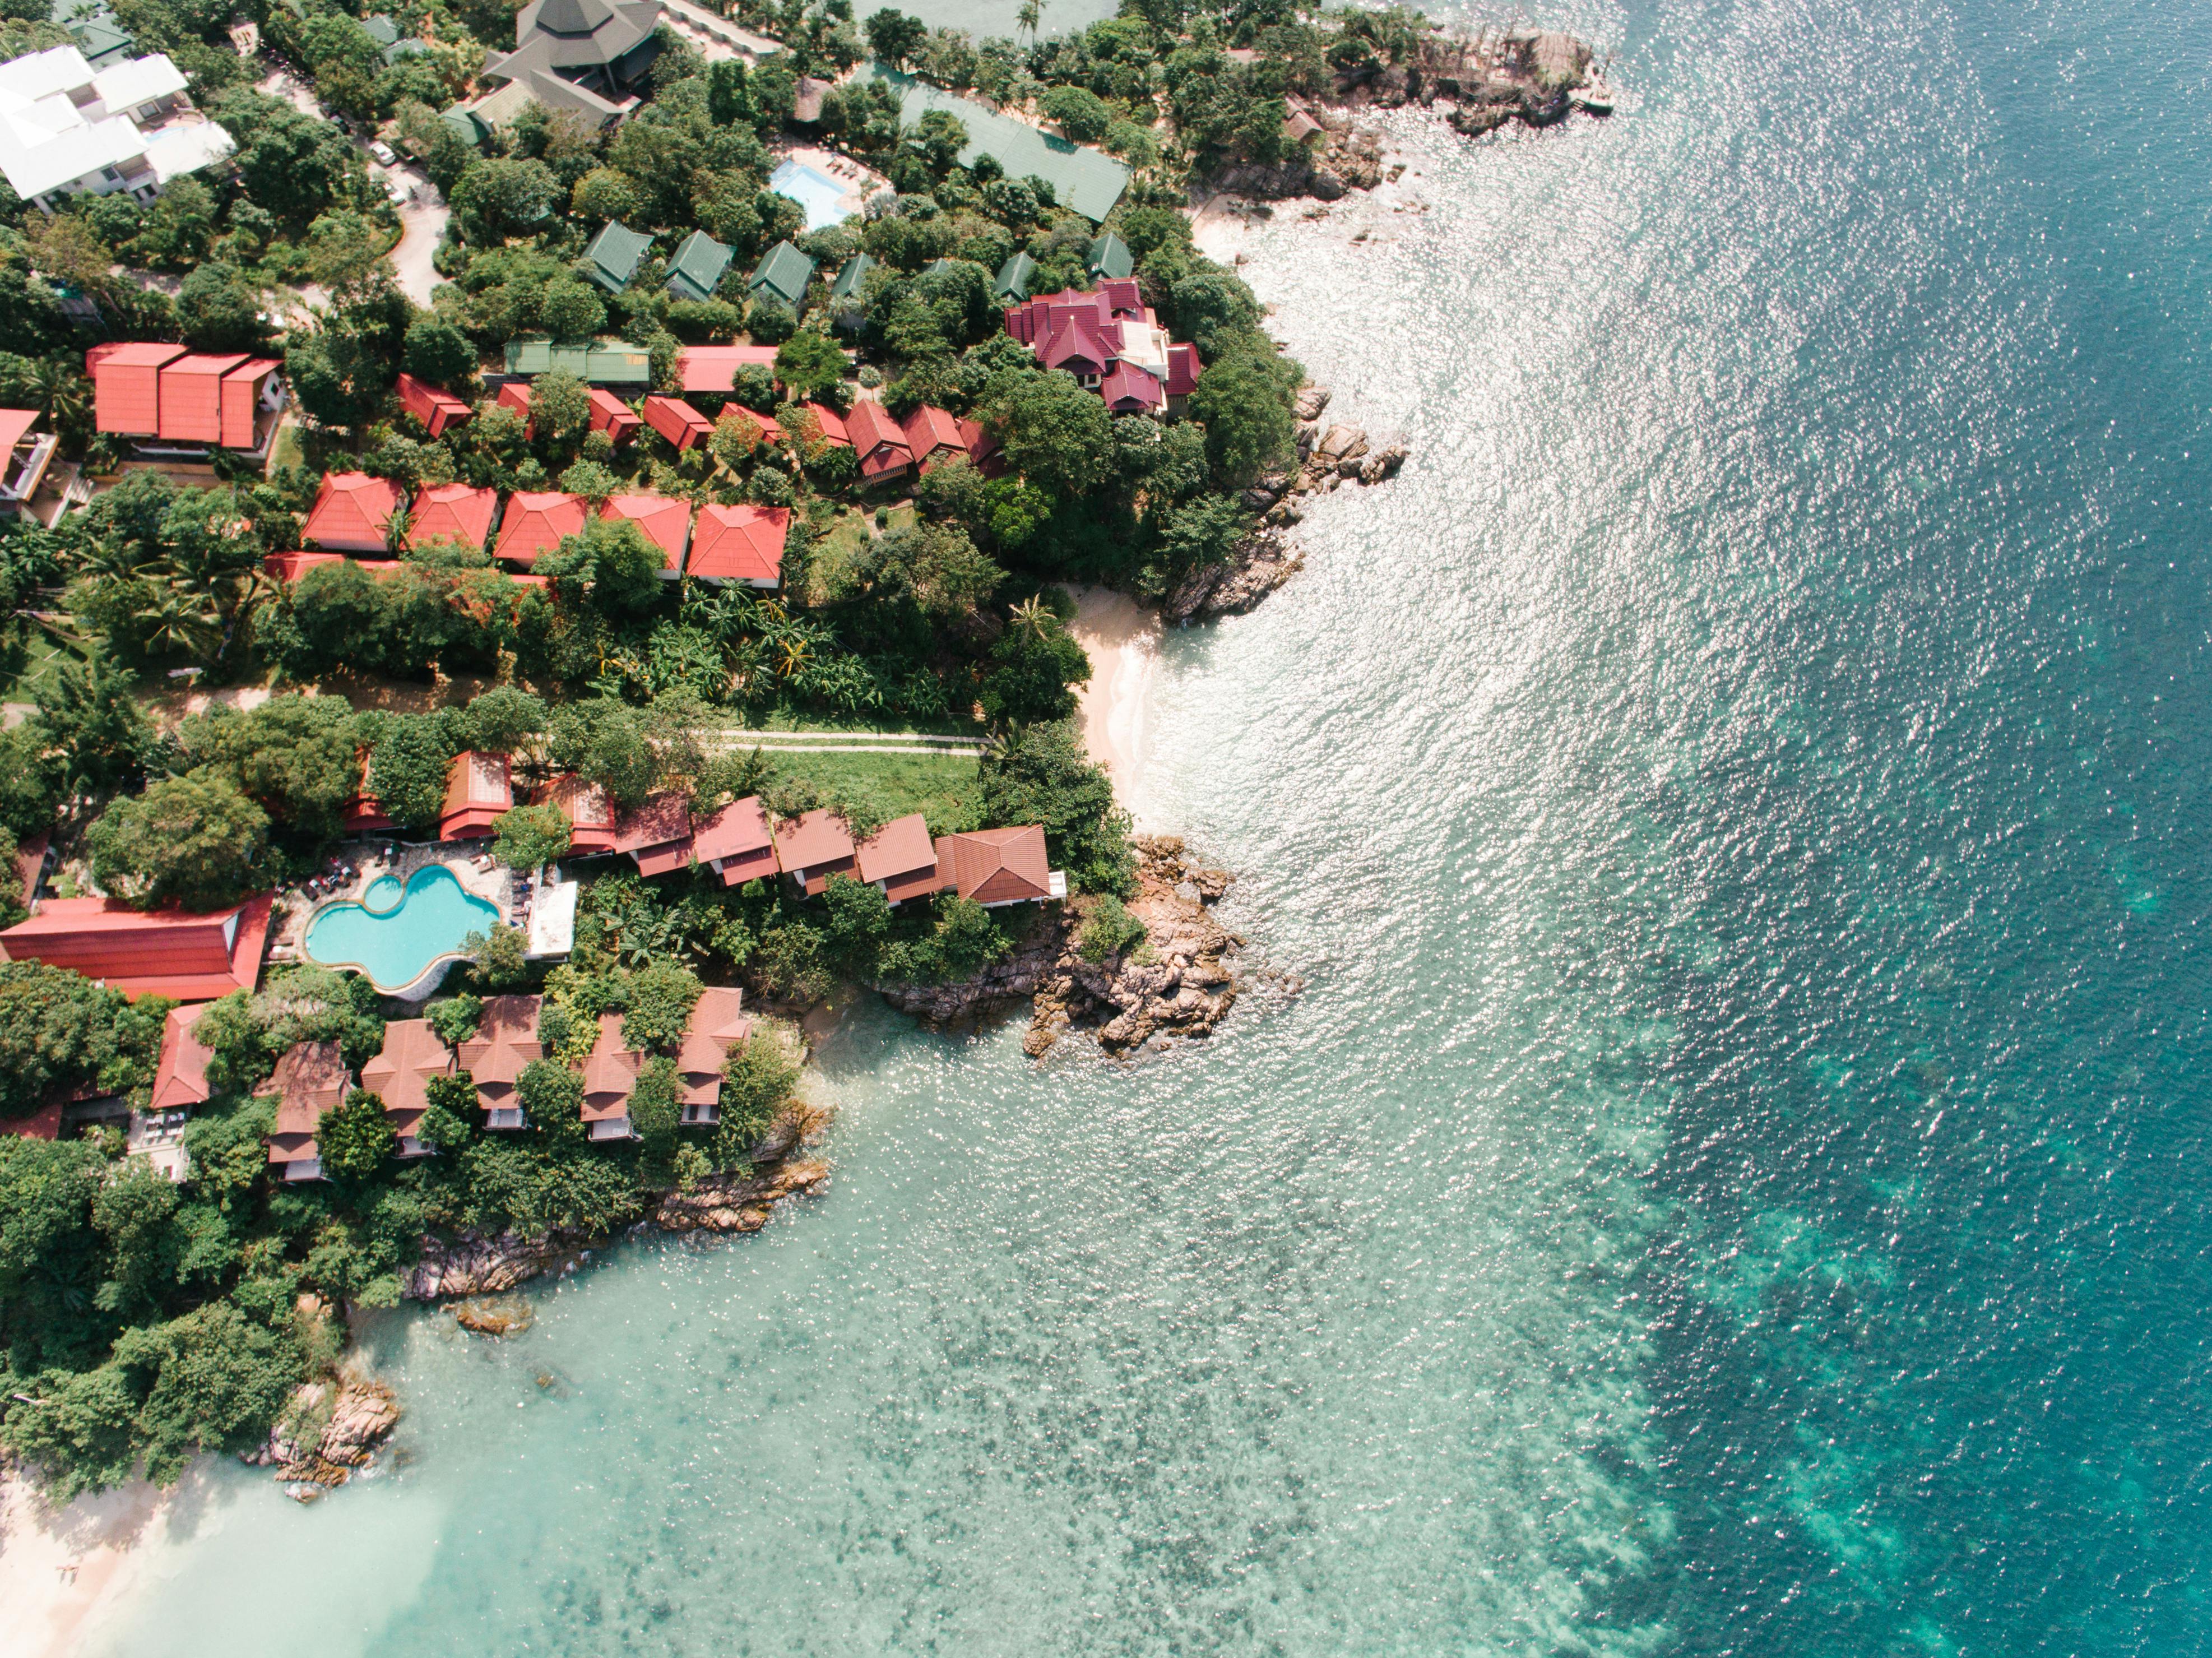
880;835;1243;1056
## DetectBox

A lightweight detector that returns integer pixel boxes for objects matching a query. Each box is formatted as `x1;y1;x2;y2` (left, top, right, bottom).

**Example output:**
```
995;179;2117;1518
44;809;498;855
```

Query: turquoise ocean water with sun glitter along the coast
91;0;2212;1658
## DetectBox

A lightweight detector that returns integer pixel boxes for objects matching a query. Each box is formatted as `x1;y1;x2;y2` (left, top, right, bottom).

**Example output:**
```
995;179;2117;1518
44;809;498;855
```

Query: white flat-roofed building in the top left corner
0;47;236;212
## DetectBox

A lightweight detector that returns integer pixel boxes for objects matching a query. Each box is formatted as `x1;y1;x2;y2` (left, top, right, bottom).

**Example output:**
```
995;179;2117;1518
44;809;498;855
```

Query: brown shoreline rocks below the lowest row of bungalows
402;1103;829;1302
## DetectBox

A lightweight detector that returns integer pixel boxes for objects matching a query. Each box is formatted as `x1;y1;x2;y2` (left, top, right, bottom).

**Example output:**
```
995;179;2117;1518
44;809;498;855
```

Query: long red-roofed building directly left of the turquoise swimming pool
0;895;270;1001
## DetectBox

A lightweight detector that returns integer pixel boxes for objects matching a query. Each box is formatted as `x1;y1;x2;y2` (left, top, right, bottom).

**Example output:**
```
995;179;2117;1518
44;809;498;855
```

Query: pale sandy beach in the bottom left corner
0;1474;170;1658
